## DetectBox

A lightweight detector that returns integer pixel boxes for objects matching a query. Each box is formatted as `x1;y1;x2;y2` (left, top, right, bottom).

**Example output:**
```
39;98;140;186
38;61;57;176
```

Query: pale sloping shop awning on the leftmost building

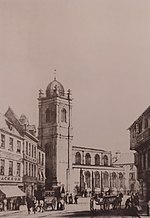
0;185;25;198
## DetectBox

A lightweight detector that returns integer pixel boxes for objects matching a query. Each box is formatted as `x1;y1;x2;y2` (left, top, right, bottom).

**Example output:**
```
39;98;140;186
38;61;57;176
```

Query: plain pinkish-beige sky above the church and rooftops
0;0;150;152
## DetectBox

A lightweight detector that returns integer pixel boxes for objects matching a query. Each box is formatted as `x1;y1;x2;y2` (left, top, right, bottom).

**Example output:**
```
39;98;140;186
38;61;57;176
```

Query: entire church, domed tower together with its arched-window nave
38;78;126;194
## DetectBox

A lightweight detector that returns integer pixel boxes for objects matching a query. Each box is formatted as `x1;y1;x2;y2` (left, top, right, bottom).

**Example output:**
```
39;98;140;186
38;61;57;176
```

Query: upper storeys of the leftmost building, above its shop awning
0;114;23;189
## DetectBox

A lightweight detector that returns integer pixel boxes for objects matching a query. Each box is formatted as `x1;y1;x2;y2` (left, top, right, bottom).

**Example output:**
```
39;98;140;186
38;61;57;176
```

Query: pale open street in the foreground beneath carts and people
0;196;146;218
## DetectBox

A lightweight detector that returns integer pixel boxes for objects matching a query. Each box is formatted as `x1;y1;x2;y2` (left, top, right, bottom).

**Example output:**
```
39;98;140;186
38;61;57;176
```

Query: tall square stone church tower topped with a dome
38;78;73;191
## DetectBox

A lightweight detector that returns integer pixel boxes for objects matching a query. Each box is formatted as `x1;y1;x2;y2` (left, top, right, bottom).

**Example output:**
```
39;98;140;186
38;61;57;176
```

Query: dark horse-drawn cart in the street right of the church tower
90;195;119;211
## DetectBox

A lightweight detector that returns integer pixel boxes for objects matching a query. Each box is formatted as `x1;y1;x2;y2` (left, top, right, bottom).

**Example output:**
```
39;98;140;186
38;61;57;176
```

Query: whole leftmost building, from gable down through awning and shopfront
0;114;25;210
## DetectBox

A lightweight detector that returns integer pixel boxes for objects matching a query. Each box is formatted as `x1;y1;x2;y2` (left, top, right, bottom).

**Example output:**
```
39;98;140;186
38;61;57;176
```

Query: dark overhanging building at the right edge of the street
129;104;150;201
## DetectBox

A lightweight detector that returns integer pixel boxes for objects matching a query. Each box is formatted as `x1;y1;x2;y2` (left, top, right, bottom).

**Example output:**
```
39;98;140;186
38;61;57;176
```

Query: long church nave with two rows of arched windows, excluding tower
72;146;125;195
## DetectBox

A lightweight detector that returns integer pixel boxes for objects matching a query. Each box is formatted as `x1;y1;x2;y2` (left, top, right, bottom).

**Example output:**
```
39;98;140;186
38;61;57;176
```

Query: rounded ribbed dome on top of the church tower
46;78;65;98
